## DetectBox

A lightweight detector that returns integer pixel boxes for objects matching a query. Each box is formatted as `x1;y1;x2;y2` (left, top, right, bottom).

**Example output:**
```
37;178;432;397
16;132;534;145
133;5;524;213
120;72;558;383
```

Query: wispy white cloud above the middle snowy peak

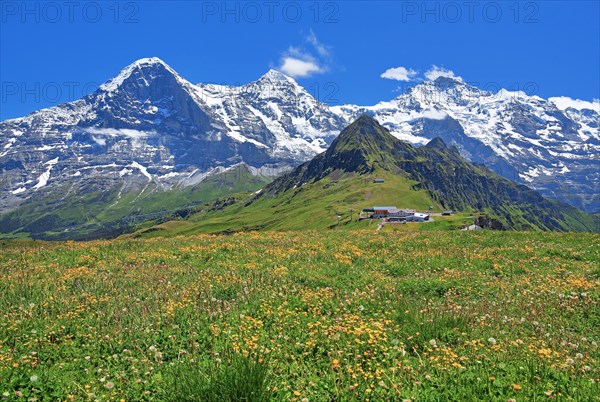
276;30;332;78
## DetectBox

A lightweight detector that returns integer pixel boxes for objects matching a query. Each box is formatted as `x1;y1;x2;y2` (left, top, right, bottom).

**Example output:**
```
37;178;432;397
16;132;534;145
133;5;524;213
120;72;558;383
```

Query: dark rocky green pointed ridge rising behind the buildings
276;116;600;231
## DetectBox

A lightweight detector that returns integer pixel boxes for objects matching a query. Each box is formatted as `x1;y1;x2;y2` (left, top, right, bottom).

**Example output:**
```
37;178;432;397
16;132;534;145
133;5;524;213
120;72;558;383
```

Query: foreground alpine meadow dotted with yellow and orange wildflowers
0;231;600;402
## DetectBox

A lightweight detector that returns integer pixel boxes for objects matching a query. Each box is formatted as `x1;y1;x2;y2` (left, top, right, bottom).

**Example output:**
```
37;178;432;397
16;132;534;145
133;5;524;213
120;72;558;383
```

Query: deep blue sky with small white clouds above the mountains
0;0;600;120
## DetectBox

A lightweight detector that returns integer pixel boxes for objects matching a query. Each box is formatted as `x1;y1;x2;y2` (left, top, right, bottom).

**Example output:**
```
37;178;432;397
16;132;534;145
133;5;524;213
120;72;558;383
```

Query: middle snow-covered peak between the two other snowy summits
197;69;345;157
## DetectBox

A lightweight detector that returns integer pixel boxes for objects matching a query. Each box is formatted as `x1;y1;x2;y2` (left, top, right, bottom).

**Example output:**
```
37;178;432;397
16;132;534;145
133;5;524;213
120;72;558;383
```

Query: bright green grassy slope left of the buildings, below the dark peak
136;171;440;236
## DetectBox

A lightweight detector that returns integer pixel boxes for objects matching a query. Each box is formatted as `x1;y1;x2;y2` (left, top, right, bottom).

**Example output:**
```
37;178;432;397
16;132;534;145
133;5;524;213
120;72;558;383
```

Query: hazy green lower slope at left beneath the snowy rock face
0;166;268;240
